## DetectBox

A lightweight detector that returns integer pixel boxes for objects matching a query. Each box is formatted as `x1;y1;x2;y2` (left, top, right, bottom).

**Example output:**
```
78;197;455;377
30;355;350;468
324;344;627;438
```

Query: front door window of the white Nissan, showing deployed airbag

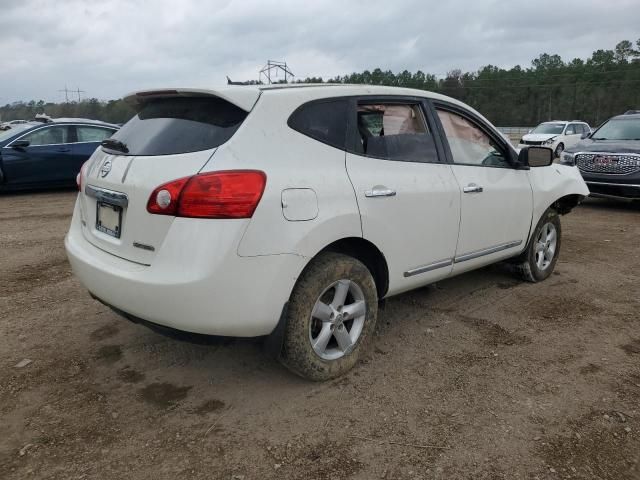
437;109;510;167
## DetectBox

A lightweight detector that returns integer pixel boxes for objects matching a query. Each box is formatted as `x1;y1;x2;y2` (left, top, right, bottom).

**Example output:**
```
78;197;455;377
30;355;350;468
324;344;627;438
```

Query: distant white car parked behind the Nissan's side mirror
518;120;591;158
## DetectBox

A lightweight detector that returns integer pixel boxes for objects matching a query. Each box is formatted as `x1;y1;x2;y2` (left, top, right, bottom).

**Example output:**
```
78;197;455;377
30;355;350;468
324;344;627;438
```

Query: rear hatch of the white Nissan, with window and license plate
80;90;259;265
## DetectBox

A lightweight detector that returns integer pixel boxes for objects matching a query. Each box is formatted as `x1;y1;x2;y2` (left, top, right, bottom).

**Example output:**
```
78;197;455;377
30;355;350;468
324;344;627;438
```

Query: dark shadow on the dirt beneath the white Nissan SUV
122;263;522;388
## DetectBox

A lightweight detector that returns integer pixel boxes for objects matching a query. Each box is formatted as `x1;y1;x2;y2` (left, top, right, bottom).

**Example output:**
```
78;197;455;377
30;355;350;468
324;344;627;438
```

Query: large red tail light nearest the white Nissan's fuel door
147;170;267;218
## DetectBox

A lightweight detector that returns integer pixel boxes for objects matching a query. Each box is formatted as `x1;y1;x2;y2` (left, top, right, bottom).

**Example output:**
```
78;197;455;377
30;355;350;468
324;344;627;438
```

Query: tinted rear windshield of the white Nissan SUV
103;97;247;155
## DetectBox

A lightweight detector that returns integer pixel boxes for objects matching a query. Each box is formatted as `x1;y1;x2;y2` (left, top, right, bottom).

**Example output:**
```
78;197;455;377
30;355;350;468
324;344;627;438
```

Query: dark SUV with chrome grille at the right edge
562;110;640;199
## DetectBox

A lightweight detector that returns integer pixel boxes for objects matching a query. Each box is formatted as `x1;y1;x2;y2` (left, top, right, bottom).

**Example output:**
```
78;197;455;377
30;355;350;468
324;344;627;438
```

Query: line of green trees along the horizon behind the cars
0;39;640;126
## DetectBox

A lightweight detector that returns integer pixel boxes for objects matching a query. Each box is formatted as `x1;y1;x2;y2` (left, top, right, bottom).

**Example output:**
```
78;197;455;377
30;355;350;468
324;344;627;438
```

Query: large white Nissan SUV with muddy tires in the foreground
65;85;589;380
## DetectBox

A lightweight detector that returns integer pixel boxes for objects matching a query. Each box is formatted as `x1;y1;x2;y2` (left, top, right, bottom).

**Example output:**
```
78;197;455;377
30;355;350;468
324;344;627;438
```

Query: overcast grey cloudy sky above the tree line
0;0;640;104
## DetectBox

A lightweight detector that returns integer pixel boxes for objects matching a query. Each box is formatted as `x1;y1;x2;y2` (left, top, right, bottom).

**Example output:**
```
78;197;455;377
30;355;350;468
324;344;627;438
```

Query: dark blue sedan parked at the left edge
0;119;118;190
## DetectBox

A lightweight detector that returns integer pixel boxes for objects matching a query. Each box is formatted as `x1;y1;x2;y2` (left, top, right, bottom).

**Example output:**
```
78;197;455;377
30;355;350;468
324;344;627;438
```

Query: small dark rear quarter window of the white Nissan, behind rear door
287;99;348;150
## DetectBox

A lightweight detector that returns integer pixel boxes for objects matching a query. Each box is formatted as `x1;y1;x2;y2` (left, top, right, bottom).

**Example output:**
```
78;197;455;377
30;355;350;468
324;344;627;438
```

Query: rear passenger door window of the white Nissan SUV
356;103;438;162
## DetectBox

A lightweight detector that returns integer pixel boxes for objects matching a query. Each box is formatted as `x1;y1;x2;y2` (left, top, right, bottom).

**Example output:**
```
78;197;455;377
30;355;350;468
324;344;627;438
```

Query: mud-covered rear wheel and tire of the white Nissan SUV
280;252;378;381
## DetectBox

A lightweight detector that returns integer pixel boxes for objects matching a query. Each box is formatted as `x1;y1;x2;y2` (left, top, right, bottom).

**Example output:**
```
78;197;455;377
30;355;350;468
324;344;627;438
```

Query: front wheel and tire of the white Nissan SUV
514;209;562;283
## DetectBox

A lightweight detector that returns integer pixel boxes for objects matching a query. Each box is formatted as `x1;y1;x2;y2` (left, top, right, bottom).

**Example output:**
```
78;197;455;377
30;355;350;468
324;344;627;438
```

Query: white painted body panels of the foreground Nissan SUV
65;86;588;336
